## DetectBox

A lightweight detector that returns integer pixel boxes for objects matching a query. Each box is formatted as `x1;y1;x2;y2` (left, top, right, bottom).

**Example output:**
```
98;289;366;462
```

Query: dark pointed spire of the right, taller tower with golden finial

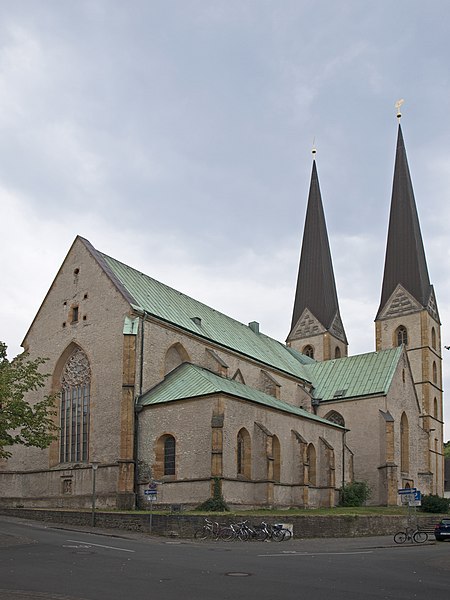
377;123;432;318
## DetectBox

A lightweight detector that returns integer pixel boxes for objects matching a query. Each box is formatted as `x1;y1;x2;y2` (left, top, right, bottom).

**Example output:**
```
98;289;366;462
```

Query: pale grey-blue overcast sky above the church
0;0;450;439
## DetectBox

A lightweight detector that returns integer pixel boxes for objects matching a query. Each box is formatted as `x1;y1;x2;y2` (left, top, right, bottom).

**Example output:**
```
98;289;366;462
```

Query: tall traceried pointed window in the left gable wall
59;348;91;462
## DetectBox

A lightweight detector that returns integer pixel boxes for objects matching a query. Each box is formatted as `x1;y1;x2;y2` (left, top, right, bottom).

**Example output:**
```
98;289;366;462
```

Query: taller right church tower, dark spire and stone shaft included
375;120;444;495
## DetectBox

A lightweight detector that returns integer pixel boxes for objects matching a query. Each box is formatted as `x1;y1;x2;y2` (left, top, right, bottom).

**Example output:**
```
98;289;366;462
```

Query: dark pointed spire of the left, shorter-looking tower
291;160;347;343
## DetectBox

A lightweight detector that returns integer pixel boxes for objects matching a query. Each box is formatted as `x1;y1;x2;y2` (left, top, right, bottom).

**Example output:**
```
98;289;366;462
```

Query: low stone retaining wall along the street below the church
0;508;439;539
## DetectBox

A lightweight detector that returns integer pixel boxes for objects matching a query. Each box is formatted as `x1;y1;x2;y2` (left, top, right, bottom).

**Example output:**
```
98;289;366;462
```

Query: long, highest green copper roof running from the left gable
90;245;309;381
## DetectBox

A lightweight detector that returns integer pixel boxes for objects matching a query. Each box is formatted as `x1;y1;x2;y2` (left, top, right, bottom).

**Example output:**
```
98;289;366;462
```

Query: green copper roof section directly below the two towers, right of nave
306;346;402;401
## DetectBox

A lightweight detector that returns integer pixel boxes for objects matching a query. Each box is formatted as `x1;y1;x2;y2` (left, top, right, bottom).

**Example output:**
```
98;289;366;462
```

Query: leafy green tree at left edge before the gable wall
0;342;58;458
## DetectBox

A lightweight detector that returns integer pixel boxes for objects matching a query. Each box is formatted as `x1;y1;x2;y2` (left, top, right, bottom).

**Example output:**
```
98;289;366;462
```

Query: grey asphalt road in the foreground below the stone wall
0;516;450;600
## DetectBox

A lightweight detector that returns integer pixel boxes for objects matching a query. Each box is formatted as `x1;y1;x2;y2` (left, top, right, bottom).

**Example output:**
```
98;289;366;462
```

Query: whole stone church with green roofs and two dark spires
0;122;443;508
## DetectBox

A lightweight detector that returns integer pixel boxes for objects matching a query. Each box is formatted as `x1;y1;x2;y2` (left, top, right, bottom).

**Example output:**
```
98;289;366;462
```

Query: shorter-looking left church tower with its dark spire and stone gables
286;161;348;361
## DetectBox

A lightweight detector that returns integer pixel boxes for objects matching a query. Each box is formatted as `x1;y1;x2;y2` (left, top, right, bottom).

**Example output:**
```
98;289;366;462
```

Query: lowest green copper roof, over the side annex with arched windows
138;363;338;427
